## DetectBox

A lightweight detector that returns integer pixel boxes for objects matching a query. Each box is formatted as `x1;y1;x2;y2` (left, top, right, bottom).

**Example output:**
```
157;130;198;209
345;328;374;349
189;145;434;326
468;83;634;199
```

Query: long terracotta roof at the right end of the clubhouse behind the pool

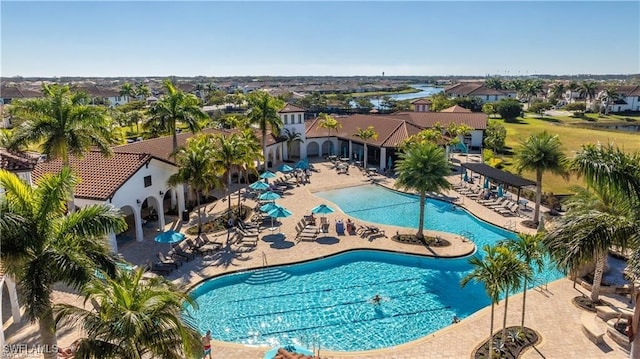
387;112;487;130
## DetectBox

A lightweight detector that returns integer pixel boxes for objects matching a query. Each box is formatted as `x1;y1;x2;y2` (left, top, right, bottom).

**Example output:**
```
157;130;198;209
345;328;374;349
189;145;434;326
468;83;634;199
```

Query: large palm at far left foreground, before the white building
0;167;126;359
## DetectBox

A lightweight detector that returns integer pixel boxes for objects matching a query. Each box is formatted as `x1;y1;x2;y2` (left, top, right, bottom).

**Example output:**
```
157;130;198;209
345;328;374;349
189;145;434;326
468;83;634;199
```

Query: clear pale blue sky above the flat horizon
0;0;640;76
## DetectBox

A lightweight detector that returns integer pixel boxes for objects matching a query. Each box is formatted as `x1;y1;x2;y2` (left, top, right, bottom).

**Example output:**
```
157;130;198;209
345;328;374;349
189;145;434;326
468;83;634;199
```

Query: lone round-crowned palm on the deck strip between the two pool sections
395;142;451;239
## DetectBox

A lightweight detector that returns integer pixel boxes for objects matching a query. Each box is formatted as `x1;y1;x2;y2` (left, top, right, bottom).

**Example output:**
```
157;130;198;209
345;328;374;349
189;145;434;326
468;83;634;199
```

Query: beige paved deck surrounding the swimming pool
3;158;630;359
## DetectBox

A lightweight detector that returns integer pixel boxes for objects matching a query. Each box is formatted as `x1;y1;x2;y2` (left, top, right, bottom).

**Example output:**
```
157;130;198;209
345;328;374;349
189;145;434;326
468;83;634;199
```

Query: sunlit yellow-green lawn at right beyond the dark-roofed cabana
502;114;640;194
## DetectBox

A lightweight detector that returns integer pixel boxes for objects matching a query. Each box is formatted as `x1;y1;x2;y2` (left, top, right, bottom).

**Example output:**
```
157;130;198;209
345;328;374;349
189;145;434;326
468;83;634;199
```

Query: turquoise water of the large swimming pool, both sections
192;185;561;351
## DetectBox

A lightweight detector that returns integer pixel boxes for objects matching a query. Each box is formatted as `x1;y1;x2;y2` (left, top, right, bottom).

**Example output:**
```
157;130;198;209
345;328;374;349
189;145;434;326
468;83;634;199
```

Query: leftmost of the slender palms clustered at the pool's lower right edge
460;245;504;357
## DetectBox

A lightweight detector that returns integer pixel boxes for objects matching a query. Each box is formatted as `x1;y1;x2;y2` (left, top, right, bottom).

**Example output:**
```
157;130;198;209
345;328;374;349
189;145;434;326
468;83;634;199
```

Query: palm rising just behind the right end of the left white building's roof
143;80;209;151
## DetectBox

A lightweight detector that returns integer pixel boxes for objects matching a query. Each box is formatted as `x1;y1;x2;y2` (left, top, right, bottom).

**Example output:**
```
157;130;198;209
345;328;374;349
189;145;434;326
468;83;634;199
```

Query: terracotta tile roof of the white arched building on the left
32;151;153;200
